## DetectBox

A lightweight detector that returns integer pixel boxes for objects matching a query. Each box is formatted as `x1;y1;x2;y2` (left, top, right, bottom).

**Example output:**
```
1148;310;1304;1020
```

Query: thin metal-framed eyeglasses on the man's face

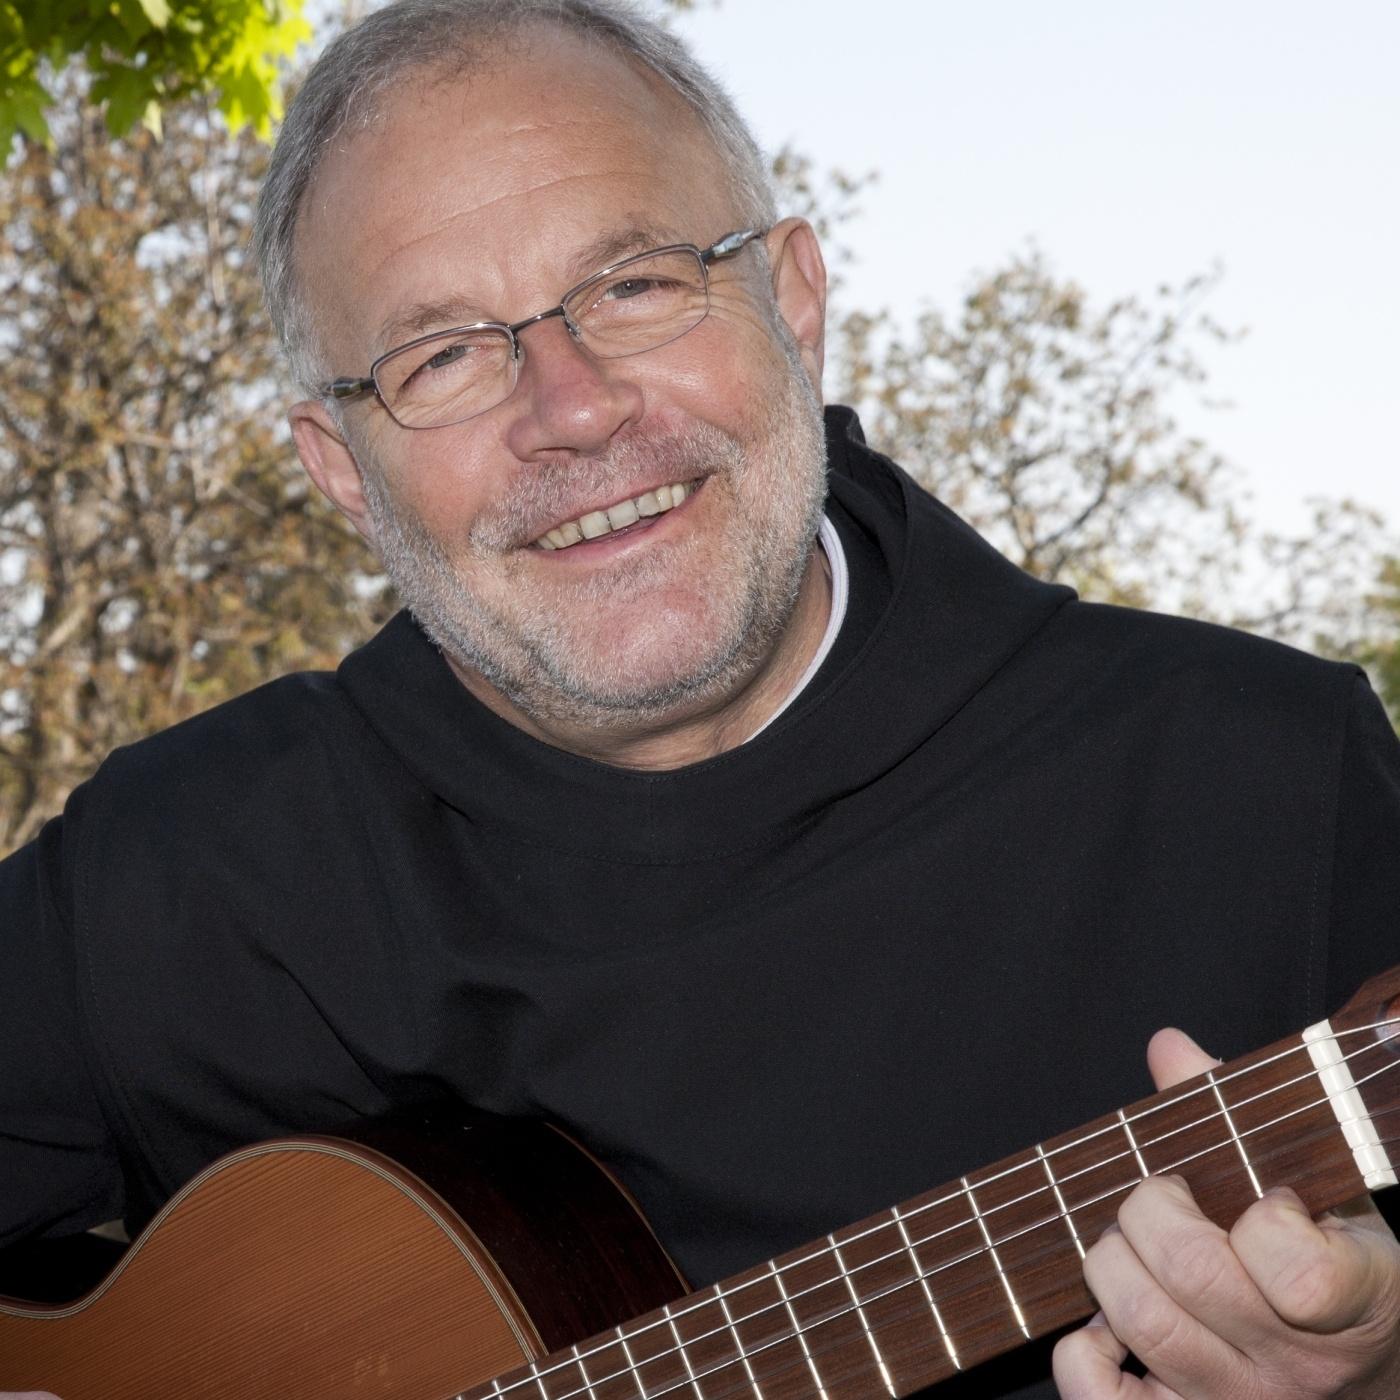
323;228;766;428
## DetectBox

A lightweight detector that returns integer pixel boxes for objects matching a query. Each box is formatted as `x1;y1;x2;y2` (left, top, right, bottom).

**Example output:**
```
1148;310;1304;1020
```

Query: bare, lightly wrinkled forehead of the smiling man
297;31;735;358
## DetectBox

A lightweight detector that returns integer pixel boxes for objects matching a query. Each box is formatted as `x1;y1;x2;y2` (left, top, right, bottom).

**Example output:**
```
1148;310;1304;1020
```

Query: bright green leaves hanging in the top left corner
0;0;311;151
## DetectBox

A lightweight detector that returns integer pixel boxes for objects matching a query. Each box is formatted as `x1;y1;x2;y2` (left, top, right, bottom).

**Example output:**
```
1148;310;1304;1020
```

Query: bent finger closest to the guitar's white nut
1229;1187;1400;1334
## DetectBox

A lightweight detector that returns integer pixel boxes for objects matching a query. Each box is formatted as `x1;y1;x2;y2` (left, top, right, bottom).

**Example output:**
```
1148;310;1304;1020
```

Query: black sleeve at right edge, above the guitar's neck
1327;676;1400;1012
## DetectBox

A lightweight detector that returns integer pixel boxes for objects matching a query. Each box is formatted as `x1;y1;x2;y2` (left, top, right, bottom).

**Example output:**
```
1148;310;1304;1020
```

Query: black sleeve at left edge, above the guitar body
0;794;123;1246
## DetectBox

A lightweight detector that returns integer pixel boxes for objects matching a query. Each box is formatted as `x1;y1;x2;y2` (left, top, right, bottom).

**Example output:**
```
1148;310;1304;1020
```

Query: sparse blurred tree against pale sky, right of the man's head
837;252;1242;605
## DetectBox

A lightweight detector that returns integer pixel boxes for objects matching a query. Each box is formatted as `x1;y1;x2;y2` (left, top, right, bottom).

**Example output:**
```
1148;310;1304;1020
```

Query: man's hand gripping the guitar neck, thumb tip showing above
1054;1030;1400;1400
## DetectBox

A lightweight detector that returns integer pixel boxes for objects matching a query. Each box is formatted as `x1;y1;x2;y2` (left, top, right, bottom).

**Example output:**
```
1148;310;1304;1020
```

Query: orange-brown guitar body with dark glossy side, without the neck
0;1117;683;1400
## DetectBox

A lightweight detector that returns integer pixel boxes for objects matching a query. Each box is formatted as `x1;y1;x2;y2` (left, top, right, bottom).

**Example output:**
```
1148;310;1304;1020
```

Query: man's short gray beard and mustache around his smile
361;356;826;731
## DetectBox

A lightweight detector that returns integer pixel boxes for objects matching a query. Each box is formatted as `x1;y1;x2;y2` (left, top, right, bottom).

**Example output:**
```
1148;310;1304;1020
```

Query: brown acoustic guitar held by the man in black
0;969;1400;1400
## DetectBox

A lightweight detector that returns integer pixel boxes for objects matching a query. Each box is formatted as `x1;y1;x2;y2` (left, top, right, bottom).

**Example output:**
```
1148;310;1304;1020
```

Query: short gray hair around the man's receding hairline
253;0;777;395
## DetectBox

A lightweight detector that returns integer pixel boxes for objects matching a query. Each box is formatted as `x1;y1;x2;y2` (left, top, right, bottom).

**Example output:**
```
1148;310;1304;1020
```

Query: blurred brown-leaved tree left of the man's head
0;80;389;848
